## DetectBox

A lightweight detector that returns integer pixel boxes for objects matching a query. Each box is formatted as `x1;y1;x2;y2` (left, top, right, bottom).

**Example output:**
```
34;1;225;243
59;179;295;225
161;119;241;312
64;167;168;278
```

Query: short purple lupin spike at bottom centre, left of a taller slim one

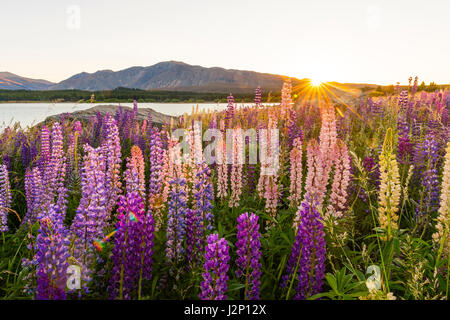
199;233;230;300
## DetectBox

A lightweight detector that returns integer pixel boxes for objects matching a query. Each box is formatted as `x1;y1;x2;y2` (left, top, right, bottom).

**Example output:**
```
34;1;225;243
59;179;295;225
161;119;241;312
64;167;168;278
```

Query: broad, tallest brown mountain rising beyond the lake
48;61;296;93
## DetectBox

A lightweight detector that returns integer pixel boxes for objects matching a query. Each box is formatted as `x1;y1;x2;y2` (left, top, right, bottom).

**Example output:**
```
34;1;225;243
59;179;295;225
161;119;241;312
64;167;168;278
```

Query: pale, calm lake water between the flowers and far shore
0;103;272;130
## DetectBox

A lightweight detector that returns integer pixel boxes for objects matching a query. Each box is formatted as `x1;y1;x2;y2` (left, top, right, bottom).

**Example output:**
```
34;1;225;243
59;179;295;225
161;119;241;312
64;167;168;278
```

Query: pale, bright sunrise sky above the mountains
0;0;450;85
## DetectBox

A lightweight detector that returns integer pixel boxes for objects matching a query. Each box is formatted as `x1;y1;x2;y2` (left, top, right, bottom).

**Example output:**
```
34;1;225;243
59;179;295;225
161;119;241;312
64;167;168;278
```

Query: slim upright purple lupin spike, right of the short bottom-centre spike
236;212;261;300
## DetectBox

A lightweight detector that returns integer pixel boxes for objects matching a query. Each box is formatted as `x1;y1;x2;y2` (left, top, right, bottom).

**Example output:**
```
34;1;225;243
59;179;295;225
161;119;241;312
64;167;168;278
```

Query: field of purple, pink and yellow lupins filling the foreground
0;82;450;300
